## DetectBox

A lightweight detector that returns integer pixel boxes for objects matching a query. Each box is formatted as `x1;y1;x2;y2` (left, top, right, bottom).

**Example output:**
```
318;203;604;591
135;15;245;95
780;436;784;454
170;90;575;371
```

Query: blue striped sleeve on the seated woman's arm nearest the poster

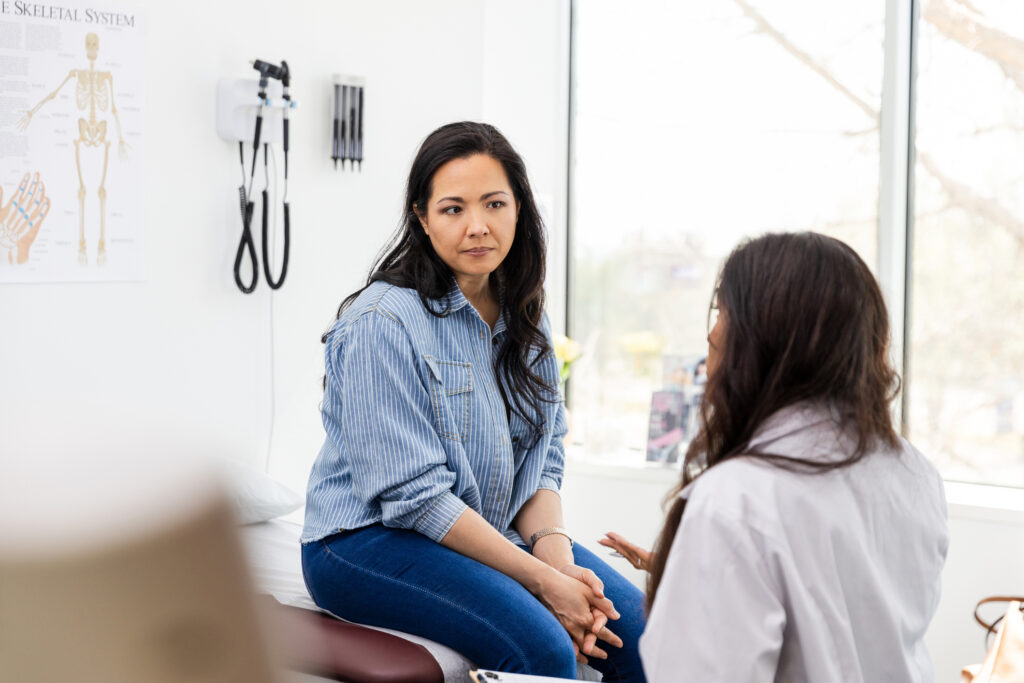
323;310;467;541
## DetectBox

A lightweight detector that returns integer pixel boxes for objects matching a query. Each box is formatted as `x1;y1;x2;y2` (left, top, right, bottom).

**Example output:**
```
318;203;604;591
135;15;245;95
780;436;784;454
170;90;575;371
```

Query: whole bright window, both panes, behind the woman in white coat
569;0;1024;485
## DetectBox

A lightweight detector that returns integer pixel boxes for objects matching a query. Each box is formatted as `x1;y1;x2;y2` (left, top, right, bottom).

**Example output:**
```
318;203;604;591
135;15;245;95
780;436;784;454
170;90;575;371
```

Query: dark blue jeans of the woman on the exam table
302;524;645;681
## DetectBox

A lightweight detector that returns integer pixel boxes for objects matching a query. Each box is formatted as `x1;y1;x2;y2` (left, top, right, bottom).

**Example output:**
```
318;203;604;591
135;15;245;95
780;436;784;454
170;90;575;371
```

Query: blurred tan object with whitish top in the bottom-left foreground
0;453;273;683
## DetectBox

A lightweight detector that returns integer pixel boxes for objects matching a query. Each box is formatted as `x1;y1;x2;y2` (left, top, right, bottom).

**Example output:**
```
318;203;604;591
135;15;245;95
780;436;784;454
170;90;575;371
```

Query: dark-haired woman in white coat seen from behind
601;232;948;682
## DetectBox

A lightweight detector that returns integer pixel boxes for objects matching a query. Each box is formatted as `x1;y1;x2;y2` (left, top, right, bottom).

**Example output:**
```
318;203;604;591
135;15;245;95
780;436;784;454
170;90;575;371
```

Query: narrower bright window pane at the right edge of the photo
906;0;1024;486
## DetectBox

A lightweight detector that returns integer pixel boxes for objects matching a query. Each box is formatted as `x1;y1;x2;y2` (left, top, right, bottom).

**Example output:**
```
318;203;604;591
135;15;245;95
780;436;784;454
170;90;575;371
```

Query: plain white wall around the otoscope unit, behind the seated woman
0;0;567;483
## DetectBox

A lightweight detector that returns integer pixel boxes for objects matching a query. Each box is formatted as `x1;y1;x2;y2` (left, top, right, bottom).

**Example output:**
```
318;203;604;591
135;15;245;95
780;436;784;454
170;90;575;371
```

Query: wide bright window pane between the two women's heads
569;0;885;462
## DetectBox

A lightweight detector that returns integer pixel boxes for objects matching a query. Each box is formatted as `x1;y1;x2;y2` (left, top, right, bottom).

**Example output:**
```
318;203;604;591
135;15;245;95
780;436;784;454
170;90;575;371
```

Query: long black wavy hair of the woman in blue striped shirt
321;121;558;435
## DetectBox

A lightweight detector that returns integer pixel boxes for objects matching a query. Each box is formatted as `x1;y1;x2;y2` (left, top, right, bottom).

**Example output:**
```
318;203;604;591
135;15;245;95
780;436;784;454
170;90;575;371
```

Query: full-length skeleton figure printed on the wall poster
18;33;130;265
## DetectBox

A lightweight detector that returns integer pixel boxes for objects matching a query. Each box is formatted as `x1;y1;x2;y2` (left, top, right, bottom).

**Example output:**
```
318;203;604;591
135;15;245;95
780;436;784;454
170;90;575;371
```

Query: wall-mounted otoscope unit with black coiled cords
217;59;298;294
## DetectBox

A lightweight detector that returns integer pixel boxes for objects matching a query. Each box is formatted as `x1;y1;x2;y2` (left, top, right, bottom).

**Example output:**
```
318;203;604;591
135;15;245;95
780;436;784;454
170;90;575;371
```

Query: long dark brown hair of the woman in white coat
647;232;900;609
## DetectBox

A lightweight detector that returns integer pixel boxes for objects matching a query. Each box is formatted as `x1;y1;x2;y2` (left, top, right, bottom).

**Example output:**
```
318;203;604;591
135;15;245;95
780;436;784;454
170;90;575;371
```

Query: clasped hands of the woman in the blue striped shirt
537;565;623;660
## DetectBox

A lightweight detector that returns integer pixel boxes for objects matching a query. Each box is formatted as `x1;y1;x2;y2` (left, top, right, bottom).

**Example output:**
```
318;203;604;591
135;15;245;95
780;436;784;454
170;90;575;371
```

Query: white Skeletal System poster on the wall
0;0;145;283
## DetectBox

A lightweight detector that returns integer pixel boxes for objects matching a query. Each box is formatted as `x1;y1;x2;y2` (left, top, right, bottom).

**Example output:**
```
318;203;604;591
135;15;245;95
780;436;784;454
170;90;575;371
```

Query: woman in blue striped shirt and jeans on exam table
302;123;644;681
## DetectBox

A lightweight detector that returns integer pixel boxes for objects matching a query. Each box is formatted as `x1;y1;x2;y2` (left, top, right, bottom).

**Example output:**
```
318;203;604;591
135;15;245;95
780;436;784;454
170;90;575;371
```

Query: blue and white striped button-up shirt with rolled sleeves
302;283;566;543
